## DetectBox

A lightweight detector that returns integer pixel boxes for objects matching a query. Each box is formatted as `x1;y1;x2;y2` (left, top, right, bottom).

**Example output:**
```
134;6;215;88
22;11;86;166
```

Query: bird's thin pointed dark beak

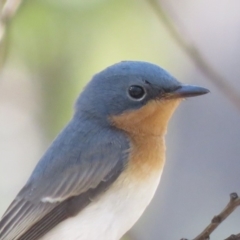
166;85;210;99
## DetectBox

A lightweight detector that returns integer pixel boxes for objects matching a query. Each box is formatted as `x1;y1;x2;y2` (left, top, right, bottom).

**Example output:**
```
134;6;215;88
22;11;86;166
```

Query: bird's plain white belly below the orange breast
41;171;162;240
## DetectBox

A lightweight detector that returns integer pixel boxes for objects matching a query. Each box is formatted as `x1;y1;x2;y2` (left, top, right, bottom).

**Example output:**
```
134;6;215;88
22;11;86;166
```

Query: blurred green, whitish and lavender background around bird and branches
0;0;240;240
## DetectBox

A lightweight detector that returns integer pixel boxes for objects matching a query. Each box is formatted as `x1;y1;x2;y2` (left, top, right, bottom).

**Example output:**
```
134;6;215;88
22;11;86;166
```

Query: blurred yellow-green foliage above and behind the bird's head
8;0;173;138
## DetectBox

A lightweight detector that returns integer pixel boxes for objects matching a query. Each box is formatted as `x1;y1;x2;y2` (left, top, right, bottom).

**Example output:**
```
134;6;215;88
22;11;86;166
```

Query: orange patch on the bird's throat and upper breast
111;99;181;180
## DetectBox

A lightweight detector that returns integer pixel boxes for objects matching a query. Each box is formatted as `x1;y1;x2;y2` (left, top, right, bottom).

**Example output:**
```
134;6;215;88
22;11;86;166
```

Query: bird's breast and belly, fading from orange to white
41;138;165;240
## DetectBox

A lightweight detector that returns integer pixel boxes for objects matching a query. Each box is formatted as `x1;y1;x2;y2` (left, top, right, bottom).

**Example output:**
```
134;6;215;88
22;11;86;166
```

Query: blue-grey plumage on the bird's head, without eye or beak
75;61;181;117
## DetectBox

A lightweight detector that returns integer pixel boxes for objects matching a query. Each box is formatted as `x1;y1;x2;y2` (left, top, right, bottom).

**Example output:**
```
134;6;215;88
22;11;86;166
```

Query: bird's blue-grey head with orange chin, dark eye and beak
76;61;209;135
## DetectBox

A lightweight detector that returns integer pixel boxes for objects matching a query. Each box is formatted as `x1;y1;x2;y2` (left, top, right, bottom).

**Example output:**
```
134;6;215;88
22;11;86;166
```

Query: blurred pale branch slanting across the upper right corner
147;0;240;111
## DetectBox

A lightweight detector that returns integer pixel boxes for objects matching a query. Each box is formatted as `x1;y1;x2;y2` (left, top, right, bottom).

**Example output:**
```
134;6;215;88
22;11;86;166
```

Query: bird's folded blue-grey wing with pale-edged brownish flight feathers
0;123;128;240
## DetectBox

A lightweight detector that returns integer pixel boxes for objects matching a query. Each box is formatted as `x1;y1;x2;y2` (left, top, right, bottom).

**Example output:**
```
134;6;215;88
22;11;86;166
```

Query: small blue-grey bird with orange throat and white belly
0;61;209;240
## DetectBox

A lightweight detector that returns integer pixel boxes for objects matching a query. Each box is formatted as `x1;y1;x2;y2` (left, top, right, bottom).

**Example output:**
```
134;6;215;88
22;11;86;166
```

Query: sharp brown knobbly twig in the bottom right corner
181;193;240;240
